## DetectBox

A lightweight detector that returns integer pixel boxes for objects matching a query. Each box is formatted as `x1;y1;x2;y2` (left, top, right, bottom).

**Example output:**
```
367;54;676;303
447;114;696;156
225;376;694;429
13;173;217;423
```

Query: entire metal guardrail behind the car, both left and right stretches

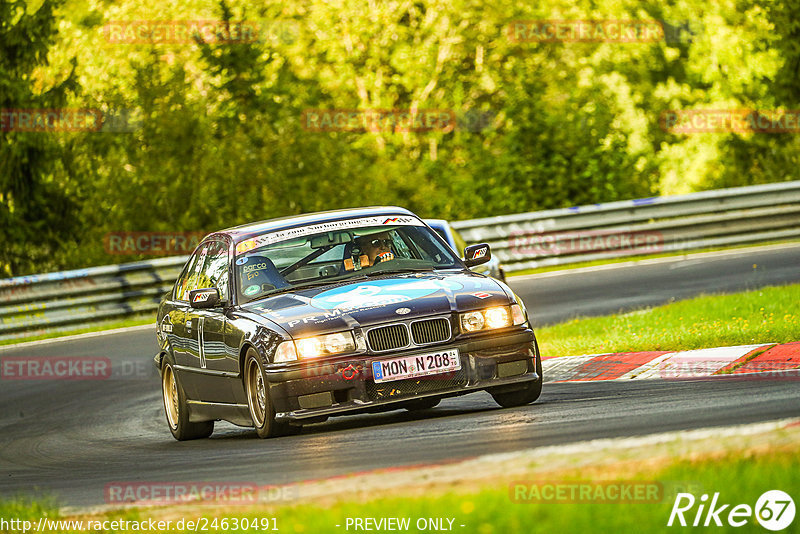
0;181;800;340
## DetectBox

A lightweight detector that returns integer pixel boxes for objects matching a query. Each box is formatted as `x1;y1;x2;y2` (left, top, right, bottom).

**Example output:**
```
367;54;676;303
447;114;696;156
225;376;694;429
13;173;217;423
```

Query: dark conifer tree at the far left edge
0;0;78;275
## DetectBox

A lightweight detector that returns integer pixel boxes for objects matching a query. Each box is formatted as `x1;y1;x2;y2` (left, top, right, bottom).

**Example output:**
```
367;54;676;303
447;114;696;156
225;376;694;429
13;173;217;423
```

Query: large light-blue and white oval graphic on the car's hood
309;280;464;311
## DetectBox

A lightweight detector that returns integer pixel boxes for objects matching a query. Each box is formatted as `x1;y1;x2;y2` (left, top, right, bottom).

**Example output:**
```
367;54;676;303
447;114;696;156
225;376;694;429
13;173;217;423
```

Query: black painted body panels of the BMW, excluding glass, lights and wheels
155;208;541;434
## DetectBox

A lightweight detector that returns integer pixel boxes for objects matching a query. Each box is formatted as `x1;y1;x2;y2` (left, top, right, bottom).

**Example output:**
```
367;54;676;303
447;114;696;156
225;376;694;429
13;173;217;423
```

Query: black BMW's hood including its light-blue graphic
243;273;513;338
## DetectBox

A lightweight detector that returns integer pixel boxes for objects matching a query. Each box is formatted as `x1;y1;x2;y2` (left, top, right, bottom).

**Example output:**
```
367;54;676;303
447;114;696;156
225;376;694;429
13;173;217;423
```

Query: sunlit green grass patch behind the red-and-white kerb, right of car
537;284;800;357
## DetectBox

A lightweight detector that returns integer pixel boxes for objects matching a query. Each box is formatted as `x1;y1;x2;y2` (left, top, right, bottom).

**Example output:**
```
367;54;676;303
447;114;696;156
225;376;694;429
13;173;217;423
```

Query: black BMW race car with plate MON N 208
155;207;542;440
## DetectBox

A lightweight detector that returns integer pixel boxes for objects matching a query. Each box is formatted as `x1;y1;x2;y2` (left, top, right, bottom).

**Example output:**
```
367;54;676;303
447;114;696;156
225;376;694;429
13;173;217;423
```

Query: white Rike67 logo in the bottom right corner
667;490;795;531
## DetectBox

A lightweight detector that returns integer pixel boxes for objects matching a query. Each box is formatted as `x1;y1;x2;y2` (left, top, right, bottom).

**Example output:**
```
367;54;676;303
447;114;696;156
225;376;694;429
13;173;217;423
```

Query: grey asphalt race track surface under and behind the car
0;246;800;506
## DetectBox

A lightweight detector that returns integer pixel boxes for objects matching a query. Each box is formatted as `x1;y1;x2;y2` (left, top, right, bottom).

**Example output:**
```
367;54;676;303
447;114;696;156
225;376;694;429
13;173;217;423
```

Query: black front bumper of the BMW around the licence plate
266;330;541;421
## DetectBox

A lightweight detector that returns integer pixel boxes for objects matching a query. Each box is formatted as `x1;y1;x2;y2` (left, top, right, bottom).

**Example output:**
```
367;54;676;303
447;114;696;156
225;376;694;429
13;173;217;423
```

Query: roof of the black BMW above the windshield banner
206;206;417;242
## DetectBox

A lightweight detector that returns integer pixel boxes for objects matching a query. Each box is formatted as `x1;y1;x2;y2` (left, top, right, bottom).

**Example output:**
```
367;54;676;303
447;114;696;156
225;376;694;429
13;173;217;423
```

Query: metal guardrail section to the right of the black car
452;181;800;272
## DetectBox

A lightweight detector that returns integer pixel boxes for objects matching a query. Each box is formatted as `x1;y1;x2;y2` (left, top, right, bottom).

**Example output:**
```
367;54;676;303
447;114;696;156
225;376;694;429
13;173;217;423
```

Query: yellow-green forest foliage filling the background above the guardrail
0;0;800;274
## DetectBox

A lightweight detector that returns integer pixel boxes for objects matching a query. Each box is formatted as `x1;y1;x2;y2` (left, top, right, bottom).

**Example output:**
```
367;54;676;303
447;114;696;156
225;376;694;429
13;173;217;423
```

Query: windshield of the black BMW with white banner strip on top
235;217;462;303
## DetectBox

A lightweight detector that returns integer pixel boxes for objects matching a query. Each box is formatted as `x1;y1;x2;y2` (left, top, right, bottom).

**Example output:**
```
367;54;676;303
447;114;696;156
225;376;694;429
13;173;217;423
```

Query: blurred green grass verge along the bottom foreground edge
0;444;800;534
